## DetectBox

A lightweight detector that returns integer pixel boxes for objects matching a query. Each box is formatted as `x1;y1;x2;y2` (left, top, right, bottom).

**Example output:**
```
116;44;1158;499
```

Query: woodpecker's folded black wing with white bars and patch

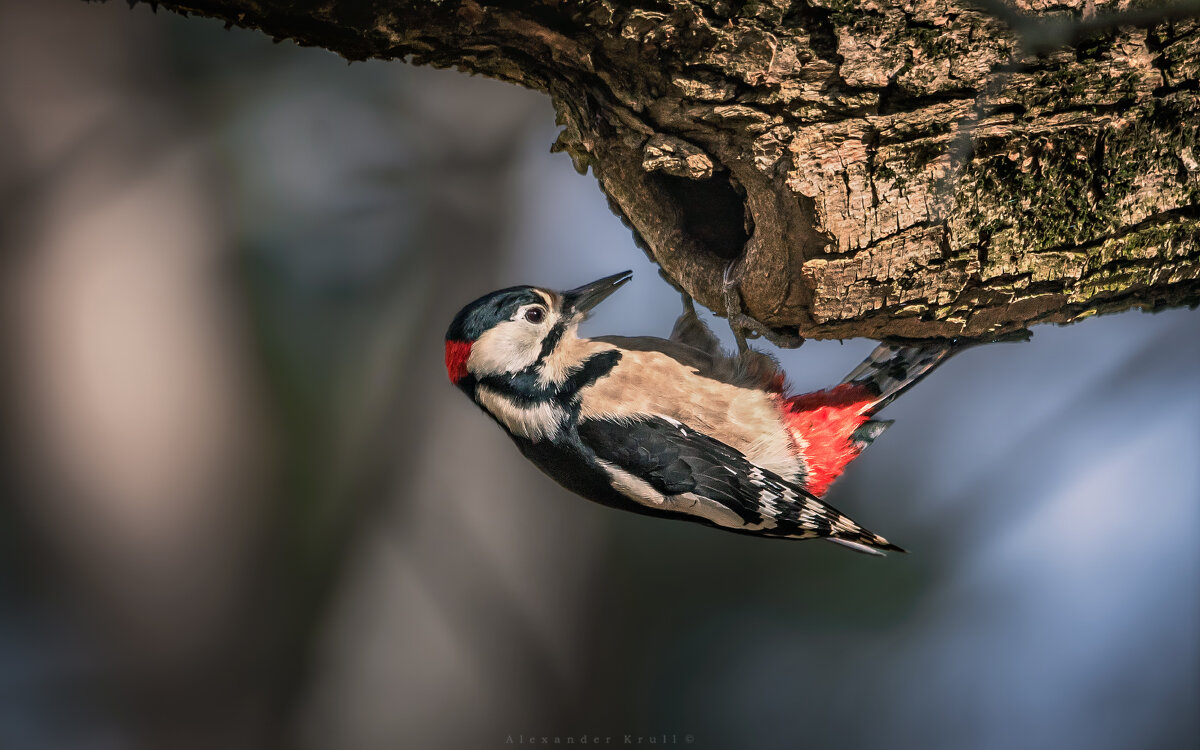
578;416;900;550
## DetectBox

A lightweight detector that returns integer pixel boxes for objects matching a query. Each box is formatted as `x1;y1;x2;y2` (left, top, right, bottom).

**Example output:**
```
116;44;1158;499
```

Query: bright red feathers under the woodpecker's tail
784;383;876;497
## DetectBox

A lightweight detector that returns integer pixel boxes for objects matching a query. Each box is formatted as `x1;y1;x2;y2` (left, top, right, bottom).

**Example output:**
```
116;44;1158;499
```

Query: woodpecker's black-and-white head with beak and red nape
446;271;632;389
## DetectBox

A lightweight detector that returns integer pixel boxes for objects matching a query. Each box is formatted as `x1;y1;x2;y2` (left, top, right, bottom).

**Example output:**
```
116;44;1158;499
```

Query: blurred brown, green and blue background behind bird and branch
0;0;1200;750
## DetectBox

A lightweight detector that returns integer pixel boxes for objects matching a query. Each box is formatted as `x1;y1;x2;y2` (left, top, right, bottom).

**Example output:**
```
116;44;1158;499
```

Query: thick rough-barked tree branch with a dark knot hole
126;0;1200;341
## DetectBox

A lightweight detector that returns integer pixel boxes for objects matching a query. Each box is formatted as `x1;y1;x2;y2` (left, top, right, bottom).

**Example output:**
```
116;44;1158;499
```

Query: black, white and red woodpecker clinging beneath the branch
445;271;955;554
